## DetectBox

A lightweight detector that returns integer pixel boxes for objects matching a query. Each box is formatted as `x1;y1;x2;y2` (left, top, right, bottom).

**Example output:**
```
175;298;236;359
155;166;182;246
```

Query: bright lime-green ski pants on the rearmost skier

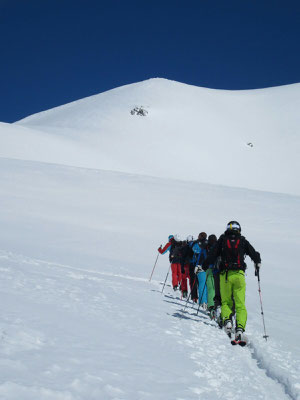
220;270;247;330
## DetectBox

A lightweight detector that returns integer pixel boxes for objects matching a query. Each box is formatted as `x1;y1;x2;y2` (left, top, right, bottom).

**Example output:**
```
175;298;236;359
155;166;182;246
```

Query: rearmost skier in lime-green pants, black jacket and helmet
203;221;261;344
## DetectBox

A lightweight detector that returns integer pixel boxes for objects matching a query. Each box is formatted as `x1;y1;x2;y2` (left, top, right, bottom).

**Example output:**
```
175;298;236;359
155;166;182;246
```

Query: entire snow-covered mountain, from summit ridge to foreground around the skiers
0;79;300;400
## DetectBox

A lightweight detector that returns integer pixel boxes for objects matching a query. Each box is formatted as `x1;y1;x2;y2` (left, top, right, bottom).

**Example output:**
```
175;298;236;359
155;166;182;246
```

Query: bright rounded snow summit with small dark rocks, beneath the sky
8;79;300;195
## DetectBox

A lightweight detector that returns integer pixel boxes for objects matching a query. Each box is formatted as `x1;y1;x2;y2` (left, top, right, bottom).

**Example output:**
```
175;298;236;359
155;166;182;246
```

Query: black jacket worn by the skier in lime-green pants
203;232;261;271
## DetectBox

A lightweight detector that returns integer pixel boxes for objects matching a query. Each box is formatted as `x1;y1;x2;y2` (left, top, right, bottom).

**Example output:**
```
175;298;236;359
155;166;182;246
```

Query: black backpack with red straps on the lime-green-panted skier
222;235;246;271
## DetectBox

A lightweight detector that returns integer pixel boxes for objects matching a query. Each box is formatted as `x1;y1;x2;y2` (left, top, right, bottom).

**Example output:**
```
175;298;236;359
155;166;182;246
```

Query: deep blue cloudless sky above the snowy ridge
0;0;300;122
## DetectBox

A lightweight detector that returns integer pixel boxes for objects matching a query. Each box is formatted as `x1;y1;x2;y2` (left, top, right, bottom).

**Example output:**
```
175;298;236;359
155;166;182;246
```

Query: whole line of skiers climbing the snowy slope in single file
158;221;261;345
